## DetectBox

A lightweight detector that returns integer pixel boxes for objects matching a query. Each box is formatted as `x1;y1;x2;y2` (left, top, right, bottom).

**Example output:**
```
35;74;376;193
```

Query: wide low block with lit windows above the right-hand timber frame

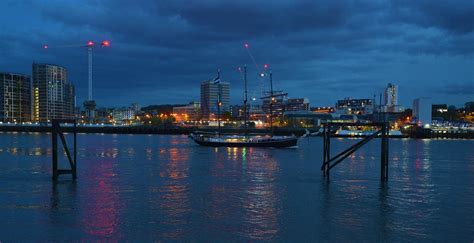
335;98;374;115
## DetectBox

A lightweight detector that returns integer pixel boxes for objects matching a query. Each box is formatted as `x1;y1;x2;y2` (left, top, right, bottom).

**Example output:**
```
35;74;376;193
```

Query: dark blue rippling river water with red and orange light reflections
0;133;474;242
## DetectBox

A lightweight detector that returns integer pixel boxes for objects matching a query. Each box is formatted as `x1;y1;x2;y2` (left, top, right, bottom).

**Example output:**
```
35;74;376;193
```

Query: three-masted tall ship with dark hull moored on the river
189;66;298;148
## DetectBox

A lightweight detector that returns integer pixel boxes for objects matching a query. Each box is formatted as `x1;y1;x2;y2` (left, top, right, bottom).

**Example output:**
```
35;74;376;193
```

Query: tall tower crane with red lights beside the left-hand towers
43;40;110;122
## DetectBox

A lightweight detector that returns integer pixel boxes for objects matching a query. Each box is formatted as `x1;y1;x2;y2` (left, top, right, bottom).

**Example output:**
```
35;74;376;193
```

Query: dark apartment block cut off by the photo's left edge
0;73;31;123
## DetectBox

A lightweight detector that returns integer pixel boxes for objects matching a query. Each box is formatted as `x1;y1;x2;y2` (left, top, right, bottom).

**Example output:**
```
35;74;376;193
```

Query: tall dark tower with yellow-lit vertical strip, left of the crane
32;63;75;122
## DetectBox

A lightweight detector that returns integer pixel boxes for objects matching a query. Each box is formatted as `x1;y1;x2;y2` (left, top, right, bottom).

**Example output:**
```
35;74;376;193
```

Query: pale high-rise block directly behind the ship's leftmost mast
201;80;230;120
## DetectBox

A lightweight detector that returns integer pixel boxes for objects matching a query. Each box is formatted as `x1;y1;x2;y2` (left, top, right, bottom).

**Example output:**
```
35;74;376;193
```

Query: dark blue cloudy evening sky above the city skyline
0;0;474;107
